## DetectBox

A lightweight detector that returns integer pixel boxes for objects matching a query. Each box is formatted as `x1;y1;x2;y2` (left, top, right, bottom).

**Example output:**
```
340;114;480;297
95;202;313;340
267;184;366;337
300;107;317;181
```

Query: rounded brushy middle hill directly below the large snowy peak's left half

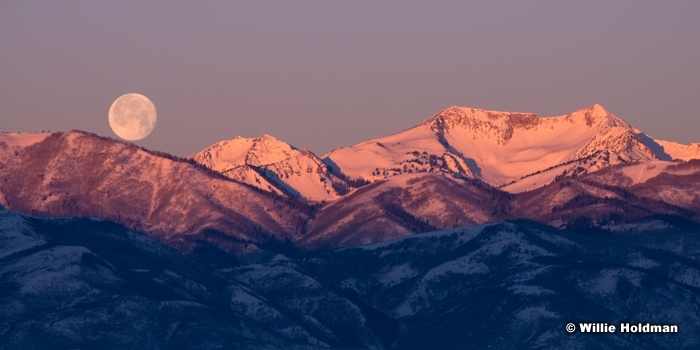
299;173;511;247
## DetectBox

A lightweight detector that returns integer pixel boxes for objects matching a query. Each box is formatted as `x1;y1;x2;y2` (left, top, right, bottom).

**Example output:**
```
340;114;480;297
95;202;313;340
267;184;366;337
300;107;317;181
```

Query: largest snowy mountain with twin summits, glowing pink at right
324;105;700;192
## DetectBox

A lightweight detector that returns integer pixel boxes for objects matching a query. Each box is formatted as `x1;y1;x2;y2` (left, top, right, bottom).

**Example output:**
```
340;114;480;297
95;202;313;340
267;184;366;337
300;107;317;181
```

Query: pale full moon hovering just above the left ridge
109;93;158;141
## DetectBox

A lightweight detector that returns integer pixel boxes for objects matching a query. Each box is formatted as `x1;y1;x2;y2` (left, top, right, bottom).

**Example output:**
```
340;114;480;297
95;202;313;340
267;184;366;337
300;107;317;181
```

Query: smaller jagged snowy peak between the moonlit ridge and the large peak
191;135;345;201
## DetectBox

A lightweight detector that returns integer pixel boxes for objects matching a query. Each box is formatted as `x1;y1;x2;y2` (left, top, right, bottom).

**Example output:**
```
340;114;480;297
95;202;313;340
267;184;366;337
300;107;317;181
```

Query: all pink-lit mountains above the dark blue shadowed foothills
0;105;700;251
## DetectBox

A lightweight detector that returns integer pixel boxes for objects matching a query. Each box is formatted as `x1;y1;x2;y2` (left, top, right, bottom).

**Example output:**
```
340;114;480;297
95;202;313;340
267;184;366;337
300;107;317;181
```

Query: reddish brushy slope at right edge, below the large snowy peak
511;160;700;232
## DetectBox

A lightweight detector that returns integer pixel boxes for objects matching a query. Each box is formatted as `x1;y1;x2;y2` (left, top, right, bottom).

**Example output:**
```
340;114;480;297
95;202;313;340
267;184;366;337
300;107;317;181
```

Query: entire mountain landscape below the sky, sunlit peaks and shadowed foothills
0;105;700;349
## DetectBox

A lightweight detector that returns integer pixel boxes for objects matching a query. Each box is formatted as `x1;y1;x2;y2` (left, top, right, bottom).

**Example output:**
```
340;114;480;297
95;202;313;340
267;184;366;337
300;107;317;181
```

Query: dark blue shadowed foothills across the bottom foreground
0;210;700;349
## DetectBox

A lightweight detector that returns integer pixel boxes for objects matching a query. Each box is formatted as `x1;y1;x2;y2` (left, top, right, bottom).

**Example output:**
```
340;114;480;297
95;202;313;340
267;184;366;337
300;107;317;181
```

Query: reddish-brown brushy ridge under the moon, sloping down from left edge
0;132;306;249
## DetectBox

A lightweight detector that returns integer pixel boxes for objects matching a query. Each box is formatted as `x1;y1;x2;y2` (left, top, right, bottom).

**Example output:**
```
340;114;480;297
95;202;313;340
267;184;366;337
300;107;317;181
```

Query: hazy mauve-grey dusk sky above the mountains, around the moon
0;0;700;156
